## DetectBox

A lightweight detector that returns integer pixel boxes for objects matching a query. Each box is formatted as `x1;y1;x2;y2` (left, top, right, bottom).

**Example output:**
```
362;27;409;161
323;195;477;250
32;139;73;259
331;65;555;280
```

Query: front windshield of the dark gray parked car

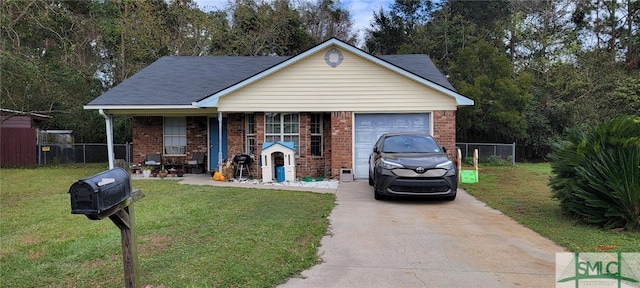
382;135;440;153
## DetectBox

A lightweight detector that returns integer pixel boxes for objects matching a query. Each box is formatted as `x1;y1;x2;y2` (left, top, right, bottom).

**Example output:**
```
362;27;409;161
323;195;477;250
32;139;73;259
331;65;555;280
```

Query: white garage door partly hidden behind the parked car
354;113;431;179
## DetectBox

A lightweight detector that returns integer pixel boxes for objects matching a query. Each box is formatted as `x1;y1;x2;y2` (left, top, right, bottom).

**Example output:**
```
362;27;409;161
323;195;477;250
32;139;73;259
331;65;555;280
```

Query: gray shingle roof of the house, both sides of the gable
88;55;455;106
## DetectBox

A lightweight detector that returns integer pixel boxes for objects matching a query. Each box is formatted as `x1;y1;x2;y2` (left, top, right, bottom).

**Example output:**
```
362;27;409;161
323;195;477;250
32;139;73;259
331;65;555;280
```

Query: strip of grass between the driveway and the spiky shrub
461;163;640;252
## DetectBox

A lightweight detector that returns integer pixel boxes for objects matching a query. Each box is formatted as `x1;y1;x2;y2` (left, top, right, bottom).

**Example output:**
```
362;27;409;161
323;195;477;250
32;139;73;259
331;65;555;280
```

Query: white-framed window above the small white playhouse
264;113;300;155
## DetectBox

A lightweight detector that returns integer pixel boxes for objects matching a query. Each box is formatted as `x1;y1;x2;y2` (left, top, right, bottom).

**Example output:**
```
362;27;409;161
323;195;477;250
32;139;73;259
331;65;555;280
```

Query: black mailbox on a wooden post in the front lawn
69;168;131;219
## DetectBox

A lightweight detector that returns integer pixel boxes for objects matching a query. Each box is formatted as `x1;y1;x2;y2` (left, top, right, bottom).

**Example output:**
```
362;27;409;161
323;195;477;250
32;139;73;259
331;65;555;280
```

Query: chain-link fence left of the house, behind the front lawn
36;143;133;165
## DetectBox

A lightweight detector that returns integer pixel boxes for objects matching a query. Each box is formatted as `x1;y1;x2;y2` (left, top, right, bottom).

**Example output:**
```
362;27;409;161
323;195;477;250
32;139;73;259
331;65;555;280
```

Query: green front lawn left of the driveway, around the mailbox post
0;166;335;287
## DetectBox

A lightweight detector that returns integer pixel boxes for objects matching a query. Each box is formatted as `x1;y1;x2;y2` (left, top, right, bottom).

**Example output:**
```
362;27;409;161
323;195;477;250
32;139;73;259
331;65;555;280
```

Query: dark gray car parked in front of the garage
369;133;458;201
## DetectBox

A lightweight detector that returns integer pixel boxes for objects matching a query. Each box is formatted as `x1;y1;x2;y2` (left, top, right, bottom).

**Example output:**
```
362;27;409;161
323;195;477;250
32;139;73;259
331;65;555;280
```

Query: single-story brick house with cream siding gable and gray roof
84;38;473;179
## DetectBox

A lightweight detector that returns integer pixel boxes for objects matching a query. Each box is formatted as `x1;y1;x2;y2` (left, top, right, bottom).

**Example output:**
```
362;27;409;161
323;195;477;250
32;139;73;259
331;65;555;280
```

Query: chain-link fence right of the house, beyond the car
456;142;516;165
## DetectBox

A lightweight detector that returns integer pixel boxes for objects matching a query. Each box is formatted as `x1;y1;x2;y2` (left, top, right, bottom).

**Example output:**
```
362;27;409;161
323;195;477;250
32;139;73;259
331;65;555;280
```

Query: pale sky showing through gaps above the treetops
194;0;393;44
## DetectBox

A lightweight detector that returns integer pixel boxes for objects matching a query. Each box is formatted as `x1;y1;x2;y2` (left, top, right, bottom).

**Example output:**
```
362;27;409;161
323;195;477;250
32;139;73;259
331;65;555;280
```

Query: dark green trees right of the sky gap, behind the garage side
365;0;640;160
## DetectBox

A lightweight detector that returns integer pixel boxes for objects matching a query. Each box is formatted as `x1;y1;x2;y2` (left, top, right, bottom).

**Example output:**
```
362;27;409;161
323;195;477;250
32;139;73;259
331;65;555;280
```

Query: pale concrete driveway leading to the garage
279;181;565;288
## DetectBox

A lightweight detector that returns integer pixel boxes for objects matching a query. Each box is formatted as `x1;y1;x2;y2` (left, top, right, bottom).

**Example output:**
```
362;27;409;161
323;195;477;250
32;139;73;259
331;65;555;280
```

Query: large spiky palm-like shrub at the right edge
549;116;640;229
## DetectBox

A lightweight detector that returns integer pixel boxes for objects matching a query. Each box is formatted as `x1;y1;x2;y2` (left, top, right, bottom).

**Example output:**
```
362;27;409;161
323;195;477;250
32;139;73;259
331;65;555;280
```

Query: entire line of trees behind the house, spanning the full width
0;0;640;159
